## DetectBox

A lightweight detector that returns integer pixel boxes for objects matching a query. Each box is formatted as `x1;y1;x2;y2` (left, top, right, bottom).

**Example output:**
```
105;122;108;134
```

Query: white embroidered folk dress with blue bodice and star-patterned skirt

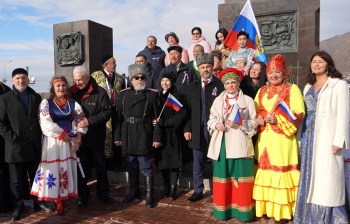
31;99;87;201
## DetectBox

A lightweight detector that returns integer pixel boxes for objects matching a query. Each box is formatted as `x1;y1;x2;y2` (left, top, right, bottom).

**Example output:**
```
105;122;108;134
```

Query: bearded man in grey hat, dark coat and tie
184;53;224;202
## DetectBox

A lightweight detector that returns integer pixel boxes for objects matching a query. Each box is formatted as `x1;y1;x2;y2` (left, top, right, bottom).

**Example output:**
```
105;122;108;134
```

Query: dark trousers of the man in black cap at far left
9;161;39;208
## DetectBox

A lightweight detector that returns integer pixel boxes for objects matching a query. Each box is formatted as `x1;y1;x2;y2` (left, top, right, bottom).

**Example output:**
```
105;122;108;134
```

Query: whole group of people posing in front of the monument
0;27;350;223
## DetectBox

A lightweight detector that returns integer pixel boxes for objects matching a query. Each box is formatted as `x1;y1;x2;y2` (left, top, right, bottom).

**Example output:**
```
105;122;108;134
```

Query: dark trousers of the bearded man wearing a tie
193;149;207;193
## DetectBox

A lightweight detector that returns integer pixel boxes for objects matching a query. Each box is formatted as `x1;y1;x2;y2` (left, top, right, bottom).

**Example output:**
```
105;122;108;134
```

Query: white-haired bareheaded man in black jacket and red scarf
71;66;113;207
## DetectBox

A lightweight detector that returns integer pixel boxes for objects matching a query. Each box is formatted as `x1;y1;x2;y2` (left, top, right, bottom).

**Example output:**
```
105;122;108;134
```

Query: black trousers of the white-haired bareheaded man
77;145;109;200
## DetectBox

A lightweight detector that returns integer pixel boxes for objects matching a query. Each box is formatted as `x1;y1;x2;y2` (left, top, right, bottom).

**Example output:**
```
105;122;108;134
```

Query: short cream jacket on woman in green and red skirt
208;91;257;160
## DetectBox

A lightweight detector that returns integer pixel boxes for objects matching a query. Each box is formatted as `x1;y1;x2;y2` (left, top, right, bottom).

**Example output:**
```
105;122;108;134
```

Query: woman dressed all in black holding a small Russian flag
155;72;187;201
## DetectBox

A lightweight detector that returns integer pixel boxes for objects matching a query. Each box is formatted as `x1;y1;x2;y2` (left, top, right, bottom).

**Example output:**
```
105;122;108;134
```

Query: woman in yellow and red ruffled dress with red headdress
253;54;304;222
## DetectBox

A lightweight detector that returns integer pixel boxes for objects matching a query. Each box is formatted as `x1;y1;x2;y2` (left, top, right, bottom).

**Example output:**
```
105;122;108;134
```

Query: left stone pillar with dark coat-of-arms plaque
53;20;113;84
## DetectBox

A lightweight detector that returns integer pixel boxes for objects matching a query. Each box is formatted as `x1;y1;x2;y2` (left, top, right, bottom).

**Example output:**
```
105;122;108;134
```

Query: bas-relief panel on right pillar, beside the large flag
257;12;297;53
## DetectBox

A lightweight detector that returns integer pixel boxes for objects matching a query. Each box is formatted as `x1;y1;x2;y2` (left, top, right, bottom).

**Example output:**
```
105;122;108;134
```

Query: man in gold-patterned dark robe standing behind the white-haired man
91;55;124;169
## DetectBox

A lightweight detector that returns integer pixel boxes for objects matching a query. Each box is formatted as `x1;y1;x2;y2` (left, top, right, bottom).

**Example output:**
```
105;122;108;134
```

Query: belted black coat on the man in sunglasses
114;87;161;156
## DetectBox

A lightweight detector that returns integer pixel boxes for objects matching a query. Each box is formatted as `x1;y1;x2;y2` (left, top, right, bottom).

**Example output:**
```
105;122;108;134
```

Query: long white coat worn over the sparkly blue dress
300;78;349;207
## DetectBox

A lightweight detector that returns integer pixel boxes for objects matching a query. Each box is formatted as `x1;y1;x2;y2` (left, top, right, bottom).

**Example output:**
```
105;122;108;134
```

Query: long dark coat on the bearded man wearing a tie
184;76;224;150
